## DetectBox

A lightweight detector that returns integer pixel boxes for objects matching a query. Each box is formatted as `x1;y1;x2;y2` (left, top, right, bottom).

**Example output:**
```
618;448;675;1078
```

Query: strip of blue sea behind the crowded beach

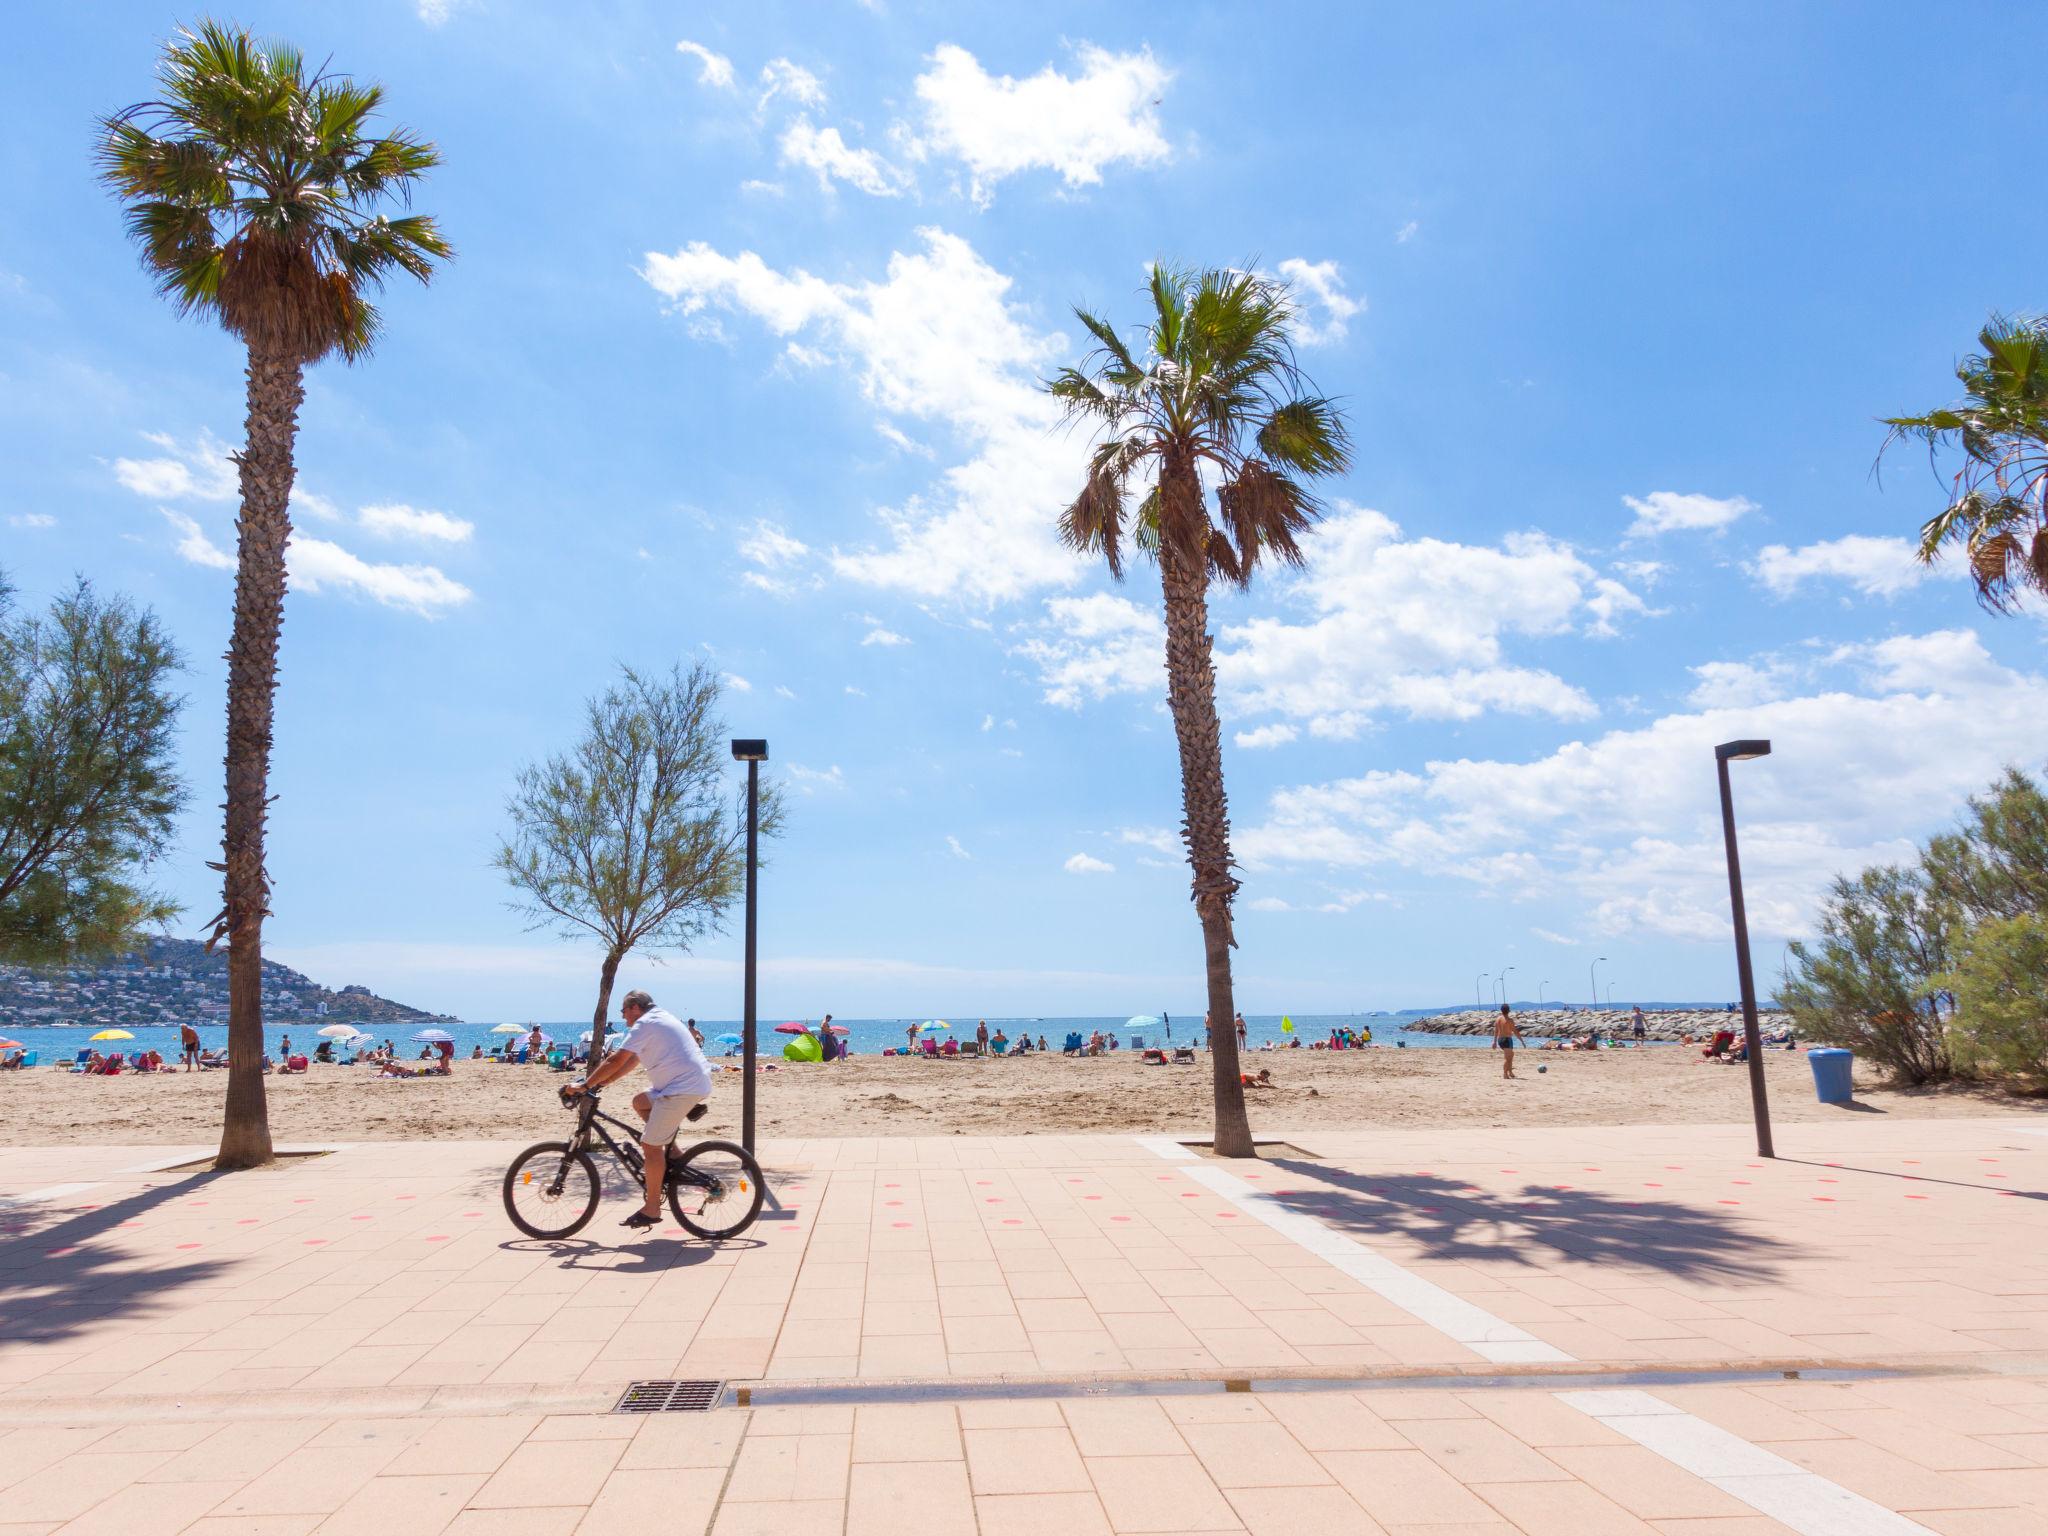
0;1008;1662;1065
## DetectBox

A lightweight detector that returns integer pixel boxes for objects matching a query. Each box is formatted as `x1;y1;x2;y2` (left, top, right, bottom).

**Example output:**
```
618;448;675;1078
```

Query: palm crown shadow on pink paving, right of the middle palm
1272;1159;1800;1282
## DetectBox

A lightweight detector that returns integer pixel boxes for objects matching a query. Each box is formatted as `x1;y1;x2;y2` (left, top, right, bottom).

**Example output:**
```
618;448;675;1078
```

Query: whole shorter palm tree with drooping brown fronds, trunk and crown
1047;266;1350;1157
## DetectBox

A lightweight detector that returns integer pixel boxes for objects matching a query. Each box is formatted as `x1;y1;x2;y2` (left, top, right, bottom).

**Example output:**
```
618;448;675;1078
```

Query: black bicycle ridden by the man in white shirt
504;1090;766;1243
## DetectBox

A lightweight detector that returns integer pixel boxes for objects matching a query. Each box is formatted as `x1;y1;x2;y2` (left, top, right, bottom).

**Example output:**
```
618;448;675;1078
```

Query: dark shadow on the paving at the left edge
0;1169;233;1343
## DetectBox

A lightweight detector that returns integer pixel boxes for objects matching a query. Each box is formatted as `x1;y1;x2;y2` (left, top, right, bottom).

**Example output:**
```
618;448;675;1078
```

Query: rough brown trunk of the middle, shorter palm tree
1159;512;1255;1157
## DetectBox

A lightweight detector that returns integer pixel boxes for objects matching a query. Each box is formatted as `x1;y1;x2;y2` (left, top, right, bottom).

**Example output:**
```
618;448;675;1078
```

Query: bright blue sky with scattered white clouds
0;0;2048;1020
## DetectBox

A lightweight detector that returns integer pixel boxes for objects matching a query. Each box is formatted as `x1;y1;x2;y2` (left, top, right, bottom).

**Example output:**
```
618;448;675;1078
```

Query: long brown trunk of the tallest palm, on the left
213;348;305;1169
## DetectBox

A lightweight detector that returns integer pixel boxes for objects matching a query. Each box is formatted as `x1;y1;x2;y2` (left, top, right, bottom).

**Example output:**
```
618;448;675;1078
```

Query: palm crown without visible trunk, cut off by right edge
1884;315;2048;612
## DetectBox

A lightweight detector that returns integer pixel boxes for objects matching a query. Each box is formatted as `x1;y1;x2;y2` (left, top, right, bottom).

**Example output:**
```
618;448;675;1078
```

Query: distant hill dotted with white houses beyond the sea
0;938;455;1028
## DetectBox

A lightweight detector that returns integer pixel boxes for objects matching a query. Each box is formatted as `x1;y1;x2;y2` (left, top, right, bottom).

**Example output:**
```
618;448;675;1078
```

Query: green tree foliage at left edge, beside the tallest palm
0;580;184;965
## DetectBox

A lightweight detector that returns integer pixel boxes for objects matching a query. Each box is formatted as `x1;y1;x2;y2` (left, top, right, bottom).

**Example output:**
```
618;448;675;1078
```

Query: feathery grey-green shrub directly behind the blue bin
1778;864;1950;1083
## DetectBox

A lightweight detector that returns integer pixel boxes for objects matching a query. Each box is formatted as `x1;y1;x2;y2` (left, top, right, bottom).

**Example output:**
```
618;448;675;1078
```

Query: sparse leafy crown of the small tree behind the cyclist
494;664;782;961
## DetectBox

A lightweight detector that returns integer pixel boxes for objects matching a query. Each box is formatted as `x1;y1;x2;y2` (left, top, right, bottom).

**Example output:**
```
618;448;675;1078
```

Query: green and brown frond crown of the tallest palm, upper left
98;20;451;362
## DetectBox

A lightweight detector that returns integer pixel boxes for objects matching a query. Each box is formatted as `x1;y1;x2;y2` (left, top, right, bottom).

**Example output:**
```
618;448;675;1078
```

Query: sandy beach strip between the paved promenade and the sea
0;1047;2048;1145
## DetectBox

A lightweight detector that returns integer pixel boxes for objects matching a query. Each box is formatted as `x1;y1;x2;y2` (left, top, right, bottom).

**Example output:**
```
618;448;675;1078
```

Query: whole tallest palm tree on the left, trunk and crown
98;23;451;1167
